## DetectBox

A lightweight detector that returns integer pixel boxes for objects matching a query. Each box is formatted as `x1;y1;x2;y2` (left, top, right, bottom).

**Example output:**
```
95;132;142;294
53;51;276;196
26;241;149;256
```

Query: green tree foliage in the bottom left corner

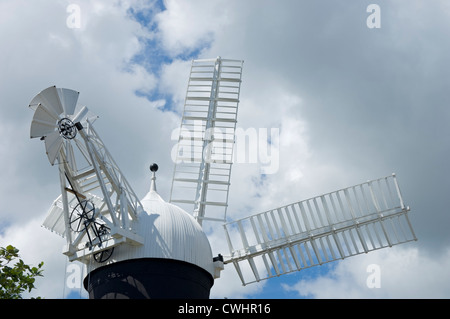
0;245;44;299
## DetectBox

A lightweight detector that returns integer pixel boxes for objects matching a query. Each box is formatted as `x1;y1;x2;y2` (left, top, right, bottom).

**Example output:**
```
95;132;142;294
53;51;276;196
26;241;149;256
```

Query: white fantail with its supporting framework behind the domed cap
30;86;142;260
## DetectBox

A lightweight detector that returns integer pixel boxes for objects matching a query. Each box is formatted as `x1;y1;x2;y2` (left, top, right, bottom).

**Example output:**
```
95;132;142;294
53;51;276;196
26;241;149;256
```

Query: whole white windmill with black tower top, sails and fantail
30;57;416;298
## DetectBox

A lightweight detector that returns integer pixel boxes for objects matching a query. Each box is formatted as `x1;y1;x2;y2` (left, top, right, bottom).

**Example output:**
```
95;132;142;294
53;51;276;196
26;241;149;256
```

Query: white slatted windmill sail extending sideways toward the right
224;174;417;285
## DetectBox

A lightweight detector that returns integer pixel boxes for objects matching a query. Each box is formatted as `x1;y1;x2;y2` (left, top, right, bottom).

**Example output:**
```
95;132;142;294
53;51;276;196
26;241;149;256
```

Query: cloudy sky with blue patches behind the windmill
0;0;450;299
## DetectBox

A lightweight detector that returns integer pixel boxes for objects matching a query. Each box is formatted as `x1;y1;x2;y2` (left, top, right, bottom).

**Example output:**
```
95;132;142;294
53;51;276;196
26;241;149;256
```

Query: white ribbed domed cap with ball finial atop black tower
138;168;214;276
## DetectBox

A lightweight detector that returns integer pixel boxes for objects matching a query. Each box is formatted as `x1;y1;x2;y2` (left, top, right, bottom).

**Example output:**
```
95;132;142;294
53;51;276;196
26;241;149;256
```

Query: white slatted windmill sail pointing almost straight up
170;57;243;224
